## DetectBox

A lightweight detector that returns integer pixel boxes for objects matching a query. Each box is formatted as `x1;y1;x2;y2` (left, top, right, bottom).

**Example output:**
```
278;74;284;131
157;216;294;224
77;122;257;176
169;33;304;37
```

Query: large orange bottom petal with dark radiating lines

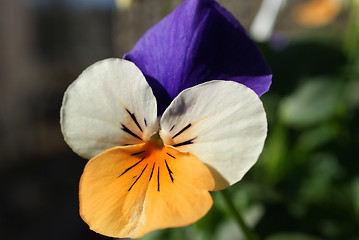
79;143;214;238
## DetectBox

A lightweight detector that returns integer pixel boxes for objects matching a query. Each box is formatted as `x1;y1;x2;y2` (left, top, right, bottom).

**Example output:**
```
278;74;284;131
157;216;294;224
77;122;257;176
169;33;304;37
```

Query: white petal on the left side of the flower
61;59;157;158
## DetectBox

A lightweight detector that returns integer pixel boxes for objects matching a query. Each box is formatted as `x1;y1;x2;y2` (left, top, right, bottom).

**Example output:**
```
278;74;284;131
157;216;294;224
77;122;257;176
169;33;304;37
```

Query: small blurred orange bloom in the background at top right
293;0;343;27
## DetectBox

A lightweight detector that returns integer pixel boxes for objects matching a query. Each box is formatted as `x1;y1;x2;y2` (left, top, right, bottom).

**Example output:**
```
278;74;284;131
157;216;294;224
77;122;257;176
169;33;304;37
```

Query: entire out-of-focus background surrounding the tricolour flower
0;0;359;240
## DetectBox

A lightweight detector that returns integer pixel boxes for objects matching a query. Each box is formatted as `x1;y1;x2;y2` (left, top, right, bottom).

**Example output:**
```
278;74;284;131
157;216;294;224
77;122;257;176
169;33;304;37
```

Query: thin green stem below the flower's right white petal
220;189;259;240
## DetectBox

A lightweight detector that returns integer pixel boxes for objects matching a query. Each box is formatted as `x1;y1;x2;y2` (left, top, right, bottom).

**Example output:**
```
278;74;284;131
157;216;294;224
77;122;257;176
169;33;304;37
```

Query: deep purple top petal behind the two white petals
124;0;272;111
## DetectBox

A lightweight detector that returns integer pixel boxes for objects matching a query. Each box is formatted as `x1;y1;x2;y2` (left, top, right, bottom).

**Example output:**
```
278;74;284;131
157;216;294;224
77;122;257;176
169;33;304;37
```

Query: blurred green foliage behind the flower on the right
139;1;359;240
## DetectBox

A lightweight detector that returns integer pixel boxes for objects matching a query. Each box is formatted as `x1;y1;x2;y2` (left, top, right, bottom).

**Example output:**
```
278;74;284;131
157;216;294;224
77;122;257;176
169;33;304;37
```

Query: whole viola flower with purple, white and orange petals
61;0;271;238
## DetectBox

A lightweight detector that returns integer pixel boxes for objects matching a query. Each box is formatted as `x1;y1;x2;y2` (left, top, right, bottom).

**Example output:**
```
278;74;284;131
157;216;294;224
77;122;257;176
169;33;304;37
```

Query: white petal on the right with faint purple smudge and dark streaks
160;81;267;190
